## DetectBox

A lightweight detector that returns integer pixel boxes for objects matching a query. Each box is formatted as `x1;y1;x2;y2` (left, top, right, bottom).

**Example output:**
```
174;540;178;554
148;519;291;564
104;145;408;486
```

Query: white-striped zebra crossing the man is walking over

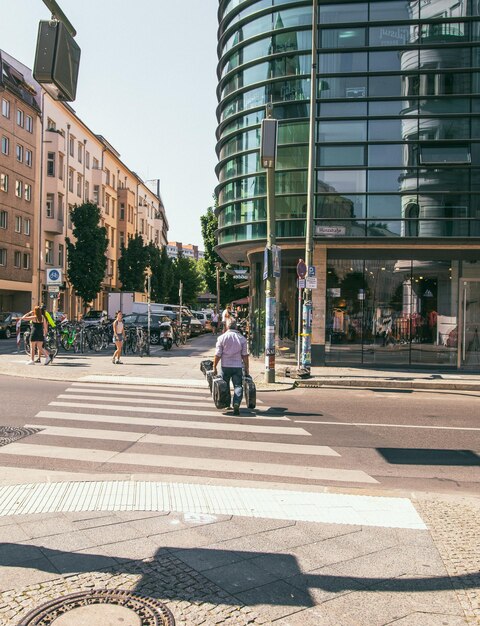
0;382;377;484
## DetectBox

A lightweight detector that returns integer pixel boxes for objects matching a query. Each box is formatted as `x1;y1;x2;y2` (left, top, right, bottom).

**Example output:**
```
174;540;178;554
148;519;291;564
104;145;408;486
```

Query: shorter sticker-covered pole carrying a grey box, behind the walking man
265;105;277;383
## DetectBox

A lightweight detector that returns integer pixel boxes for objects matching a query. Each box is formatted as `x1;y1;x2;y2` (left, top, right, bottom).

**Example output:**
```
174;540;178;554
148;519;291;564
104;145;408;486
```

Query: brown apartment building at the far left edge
0;51;40;312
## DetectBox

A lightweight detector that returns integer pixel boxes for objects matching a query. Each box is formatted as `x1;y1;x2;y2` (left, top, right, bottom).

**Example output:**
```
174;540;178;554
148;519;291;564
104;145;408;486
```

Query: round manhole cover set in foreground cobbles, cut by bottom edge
18;590;175;626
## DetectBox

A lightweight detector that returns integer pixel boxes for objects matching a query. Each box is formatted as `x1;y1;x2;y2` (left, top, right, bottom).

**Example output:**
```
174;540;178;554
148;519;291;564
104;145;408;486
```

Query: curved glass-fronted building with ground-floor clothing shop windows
217;0;480;369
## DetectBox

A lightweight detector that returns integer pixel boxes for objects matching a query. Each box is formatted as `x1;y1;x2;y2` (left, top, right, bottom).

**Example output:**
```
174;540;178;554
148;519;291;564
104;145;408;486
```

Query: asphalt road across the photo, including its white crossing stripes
0;377;480;495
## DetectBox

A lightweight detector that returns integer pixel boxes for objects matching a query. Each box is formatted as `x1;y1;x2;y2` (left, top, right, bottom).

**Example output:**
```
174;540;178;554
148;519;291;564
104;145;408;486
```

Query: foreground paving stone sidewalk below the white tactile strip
0;497;480;626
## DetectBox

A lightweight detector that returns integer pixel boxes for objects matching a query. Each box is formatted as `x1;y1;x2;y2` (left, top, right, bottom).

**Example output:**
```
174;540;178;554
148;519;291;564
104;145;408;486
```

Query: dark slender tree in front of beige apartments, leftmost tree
65;202;108;308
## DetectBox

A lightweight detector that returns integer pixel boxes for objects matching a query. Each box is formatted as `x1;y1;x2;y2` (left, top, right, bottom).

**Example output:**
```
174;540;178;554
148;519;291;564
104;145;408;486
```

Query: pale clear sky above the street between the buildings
0;0;218;248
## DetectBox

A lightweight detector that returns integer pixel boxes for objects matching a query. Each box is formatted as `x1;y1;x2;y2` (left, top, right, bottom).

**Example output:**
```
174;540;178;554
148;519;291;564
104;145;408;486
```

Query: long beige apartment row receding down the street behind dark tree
39;100;168;319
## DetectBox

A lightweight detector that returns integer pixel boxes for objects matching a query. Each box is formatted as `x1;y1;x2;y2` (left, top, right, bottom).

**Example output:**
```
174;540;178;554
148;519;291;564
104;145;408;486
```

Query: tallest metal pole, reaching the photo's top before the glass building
302;0;318;370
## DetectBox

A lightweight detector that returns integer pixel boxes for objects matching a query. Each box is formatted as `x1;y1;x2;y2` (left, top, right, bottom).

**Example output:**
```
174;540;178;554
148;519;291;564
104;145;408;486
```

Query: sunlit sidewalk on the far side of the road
0;335;480;391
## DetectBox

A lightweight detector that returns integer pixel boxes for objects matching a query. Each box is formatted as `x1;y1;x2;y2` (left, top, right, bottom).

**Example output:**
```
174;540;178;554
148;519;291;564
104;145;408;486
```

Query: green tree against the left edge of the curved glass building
200;207;239;305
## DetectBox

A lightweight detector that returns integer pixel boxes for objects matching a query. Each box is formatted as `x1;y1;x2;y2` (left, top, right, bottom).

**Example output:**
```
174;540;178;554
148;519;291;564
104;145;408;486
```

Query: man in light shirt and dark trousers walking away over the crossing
213;318;249;415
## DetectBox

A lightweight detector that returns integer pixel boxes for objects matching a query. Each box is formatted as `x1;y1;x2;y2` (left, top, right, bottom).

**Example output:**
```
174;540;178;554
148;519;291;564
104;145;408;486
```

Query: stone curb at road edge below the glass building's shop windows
294;378;480;391
